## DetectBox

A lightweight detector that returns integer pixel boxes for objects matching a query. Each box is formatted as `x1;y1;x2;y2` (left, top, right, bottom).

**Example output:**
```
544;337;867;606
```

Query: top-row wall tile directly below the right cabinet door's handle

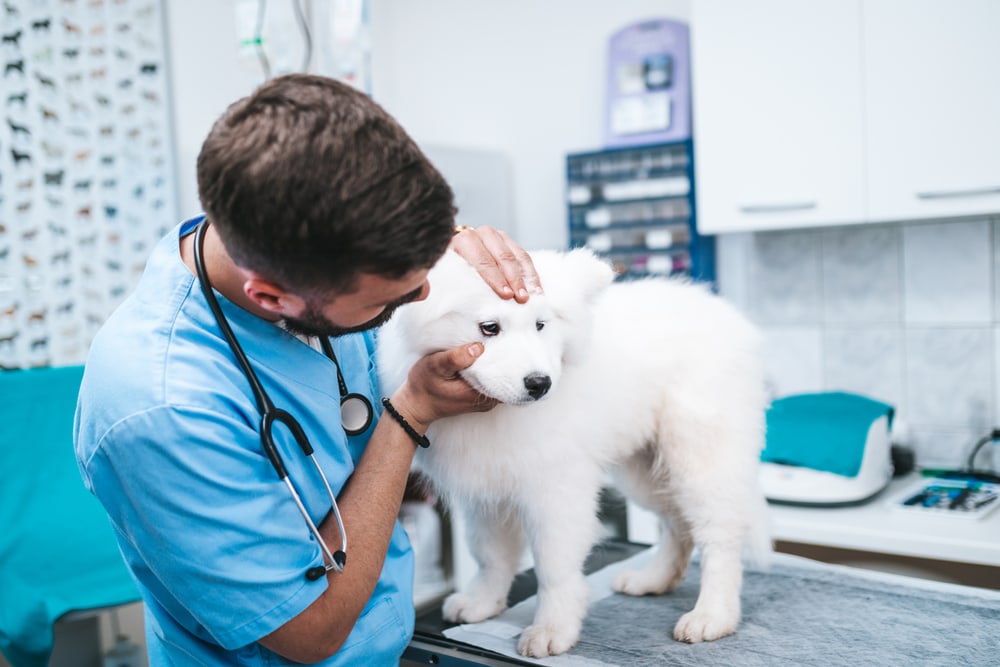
903;220;993;325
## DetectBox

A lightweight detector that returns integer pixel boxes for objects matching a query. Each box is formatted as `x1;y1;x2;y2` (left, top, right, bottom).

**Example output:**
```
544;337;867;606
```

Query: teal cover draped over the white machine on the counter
760;392;894;477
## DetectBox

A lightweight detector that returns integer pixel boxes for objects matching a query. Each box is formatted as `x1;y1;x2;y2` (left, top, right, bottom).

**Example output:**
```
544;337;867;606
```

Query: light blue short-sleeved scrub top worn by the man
75;218;414;667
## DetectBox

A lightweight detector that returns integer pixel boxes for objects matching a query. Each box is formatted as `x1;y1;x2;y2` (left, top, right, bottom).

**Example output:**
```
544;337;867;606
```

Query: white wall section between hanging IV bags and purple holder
371;0;690;248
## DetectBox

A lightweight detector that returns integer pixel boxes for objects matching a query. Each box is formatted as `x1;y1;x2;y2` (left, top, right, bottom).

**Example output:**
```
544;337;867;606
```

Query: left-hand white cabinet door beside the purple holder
691;0;865;234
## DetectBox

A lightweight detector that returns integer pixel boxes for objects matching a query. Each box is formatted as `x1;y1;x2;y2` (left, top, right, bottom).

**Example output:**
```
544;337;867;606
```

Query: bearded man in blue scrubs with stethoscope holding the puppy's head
75;75;539;667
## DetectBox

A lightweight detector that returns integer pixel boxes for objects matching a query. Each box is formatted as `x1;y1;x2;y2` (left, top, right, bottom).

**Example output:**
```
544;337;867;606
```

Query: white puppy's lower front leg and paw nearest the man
442;509;524;623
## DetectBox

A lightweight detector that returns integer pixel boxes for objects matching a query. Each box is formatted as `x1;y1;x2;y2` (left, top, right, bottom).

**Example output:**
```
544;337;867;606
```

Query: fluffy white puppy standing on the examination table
377;249;770;657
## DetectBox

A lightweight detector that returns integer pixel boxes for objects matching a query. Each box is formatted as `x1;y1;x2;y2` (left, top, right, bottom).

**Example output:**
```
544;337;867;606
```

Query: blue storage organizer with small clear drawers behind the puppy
566;140;715;287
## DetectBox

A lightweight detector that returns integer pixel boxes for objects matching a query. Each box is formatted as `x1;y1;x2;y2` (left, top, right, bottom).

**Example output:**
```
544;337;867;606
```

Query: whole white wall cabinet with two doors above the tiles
691;0;1000;234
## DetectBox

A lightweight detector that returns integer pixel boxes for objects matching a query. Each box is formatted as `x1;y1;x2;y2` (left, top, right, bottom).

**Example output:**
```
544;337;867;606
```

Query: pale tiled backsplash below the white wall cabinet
717;218;1000;467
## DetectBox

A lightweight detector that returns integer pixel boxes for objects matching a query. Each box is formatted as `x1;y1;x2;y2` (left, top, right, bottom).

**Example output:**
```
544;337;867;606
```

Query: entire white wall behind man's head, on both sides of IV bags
164;0;690;248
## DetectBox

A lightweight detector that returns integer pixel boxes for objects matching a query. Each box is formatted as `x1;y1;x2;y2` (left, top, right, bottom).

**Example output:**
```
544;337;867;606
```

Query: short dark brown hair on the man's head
198;74;455;292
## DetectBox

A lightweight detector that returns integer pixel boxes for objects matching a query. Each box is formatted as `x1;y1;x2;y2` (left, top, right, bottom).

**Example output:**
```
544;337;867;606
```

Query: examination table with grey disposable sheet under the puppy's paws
402;542;1000;667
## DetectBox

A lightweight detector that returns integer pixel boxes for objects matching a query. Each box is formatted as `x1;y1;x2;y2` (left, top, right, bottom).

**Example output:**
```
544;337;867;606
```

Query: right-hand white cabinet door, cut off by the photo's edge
864;0;1000;220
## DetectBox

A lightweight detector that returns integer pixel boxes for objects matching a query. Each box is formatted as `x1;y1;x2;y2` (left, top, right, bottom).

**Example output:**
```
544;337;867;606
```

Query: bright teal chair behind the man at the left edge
0;366;139;667
